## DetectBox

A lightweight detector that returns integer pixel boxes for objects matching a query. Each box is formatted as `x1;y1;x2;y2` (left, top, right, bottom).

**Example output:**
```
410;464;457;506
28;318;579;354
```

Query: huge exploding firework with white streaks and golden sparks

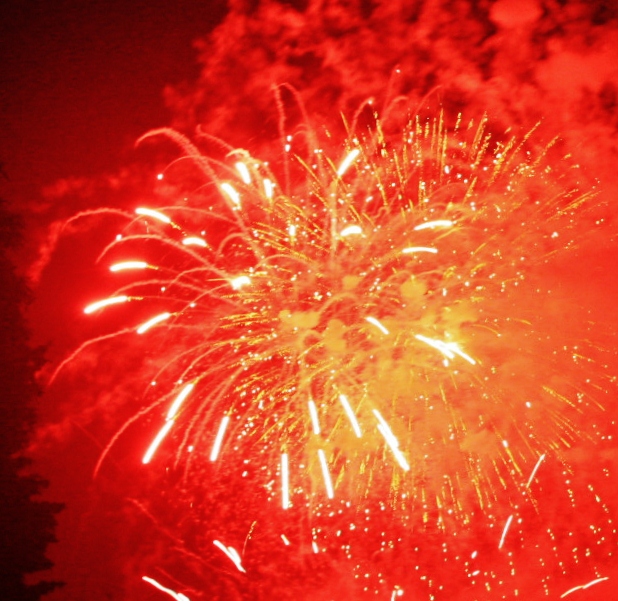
59;109;615;599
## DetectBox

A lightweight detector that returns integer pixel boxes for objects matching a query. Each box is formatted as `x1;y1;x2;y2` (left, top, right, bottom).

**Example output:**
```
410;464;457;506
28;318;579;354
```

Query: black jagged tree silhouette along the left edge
0;201;62;601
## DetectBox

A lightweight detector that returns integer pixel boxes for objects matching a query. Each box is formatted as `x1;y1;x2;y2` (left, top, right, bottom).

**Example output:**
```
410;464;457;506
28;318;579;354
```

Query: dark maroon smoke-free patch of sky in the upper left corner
0;0;225;211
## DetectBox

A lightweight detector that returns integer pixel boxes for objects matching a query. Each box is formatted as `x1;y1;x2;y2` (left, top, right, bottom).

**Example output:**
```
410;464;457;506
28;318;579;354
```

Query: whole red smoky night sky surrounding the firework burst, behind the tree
0;0;618;601
